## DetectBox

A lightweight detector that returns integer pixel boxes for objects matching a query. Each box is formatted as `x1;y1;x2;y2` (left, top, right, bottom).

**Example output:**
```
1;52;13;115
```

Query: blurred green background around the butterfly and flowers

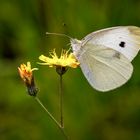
0;0;140;140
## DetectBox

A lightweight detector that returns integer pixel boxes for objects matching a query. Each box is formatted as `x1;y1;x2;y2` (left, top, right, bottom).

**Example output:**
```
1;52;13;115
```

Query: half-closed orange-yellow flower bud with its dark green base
18;62;38;96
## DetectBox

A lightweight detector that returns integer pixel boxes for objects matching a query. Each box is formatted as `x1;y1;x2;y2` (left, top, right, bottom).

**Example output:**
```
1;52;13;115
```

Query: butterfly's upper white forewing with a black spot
82;26;140;61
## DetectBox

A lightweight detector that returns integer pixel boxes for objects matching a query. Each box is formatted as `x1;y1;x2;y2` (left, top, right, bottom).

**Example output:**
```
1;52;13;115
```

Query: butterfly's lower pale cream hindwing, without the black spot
78;44;133;92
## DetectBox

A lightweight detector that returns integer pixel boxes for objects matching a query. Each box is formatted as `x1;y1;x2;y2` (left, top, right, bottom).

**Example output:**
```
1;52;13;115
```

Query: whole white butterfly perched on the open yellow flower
70;26;140;92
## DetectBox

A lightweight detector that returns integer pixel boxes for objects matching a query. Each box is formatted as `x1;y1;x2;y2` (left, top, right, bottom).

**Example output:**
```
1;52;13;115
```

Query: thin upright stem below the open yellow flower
60;75;64;128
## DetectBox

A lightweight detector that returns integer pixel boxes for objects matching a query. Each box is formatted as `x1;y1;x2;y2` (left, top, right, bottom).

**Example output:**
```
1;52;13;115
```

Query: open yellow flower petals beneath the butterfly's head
39;50;79;68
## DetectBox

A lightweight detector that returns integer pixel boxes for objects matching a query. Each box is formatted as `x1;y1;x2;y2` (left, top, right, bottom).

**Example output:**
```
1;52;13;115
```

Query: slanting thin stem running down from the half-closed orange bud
35;97;68;140
